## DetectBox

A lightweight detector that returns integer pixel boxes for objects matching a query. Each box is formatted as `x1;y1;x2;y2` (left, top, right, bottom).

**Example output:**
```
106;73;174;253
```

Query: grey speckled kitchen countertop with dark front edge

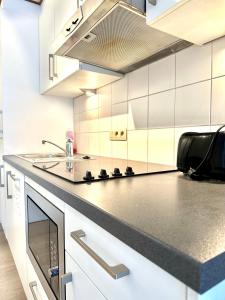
3;155;225;294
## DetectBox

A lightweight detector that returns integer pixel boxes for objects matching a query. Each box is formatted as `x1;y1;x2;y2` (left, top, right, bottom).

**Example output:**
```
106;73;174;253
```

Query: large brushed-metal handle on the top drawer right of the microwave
70;230;129;279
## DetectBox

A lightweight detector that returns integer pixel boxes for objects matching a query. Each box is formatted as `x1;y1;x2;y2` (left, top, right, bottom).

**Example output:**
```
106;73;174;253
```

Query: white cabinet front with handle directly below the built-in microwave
26;255;49;300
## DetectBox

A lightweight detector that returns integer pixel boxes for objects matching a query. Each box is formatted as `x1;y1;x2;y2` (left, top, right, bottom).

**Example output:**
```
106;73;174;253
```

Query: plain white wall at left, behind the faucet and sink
1;0;73;154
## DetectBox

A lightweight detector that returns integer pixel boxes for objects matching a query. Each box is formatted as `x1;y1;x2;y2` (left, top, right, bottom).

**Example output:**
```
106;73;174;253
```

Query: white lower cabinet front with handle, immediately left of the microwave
3;163;27;291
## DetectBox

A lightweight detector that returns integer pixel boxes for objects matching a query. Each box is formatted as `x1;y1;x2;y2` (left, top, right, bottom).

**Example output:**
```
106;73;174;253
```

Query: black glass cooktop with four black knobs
33;155;177;183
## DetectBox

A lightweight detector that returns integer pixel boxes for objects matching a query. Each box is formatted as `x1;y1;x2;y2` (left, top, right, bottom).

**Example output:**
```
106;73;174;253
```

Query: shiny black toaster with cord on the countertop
177;125;225;180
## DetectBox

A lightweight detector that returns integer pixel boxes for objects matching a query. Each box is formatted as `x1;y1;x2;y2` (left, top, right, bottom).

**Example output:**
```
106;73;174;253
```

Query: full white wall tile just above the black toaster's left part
175;80;211;127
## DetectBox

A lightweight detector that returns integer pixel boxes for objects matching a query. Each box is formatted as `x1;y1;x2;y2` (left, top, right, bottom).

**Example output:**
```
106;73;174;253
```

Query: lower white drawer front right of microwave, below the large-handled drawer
66;253;106;300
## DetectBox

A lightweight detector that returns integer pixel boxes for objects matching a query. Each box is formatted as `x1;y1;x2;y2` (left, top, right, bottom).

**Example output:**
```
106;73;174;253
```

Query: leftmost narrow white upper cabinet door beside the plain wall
39;0;55;93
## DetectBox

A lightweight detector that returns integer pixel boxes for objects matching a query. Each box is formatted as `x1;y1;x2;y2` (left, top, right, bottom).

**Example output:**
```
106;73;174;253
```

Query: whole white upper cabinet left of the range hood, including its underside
39;0;123;98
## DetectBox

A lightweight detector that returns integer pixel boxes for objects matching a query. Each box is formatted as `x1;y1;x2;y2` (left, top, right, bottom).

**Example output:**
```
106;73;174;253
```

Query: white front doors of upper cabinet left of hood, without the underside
39;0;80;95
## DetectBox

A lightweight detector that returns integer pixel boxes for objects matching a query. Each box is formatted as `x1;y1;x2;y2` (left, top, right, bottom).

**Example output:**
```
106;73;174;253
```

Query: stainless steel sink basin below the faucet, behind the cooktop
17;153;66;163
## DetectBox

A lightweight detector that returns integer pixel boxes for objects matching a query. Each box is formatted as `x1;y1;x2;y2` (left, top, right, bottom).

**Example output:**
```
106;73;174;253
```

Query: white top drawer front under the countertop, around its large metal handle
65;205;185;300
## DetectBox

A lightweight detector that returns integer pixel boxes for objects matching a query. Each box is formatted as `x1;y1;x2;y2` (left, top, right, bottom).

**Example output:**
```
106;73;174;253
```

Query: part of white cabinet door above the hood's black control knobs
54;0;77;36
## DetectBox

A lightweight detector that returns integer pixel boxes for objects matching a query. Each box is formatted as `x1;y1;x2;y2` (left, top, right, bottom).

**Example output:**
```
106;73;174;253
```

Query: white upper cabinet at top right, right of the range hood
146;0;225;45
